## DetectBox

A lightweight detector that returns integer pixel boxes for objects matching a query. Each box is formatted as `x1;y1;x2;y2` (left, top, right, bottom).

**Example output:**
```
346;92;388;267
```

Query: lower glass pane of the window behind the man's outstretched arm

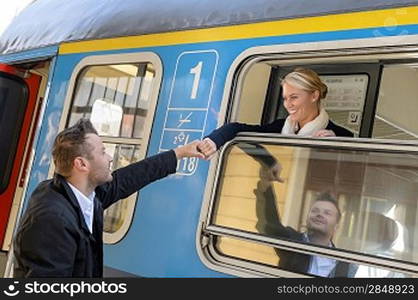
103;143;140;233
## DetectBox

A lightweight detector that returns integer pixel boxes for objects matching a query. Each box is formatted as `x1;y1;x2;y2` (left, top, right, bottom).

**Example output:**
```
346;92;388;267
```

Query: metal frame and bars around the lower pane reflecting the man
203;133;418;277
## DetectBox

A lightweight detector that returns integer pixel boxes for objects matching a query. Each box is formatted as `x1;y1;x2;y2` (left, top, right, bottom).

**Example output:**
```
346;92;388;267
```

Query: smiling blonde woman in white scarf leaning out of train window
198;68;353;158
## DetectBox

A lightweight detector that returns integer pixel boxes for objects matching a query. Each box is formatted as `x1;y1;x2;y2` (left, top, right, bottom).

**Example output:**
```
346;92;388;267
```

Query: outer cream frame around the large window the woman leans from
196;35;418;277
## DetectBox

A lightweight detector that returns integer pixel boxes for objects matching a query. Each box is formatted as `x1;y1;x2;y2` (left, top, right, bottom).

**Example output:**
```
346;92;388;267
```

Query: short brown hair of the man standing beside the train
52;118;97;177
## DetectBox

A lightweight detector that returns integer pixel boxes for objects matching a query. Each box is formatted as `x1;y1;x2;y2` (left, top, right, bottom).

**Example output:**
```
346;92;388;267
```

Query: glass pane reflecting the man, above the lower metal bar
211;143;418;276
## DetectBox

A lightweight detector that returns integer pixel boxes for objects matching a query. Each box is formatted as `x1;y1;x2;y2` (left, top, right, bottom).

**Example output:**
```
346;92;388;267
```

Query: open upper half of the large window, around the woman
229;56;418;140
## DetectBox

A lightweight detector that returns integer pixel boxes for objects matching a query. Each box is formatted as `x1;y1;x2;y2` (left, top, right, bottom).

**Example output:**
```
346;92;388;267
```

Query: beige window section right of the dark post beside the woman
373;64;418;140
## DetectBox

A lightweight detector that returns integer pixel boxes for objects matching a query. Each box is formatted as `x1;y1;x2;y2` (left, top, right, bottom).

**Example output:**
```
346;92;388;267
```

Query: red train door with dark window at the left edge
0;64;41;245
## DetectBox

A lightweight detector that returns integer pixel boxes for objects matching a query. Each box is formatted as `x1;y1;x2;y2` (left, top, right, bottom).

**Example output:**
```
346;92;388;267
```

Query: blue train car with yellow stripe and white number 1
0;0;418;277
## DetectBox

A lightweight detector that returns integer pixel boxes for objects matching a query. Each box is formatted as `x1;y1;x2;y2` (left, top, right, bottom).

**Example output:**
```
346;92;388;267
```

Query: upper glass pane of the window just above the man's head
69;63;155;138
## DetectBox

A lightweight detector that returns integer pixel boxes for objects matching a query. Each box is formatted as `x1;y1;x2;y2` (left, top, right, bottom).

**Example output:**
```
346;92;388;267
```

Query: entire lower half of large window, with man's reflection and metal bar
206;134;418;277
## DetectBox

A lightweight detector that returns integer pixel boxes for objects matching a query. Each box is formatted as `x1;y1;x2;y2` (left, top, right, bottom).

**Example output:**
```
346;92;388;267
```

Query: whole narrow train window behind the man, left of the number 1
68;62;161;243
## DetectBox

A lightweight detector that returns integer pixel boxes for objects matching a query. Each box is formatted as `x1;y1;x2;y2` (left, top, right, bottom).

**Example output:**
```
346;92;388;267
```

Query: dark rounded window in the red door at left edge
0;73;29;194
